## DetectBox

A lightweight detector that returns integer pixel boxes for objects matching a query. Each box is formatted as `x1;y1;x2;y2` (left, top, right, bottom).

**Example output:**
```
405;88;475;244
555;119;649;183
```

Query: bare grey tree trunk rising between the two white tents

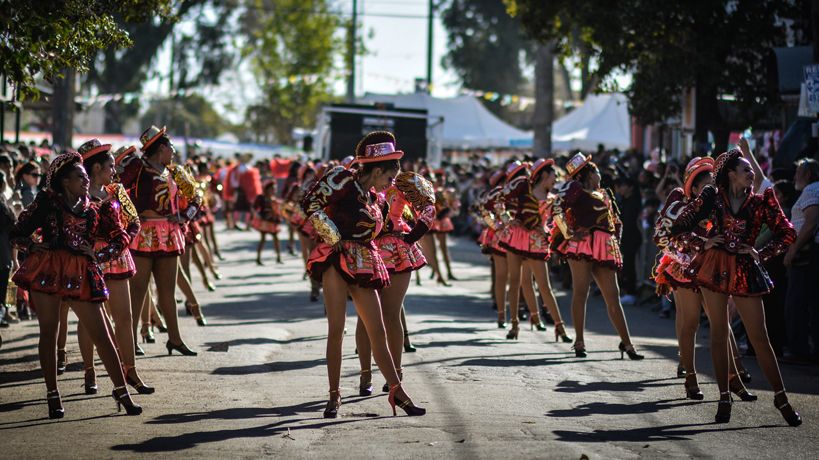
532;43;555;158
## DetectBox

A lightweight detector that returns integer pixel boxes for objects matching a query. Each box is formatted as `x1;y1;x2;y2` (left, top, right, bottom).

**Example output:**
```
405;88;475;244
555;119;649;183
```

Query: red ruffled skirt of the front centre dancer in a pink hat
307;240;390;289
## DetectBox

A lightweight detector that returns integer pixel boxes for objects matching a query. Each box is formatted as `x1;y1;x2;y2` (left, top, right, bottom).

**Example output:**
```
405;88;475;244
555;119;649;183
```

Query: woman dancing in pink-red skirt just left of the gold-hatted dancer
499;158;572;343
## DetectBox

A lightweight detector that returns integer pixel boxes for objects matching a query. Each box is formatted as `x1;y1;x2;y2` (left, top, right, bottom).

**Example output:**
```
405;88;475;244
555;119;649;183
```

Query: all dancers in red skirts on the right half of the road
474;142;801;426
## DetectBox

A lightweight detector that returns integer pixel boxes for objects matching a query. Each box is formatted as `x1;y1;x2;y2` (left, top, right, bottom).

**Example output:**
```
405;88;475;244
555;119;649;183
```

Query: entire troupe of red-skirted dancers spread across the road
10;126;801;426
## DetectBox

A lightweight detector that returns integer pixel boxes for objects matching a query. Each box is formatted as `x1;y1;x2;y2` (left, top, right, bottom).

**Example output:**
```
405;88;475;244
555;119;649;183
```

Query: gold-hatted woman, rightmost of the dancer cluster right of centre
552;153;643;360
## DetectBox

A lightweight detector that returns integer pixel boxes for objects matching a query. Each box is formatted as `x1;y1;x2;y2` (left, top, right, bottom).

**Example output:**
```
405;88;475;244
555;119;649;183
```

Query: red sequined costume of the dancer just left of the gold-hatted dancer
498;175;551;260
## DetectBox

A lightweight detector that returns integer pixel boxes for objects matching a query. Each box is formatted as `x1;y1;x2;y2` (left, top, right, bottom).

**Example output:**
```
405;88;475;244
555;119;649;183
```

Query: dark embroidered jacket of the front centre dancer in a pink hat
301;166;384;245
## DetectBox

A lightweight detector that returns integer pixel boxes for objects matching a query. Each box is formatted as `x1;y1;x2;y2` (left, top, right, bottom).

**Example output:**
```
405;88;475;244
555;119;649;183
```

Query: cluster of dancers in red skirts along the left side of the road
15;126;218;418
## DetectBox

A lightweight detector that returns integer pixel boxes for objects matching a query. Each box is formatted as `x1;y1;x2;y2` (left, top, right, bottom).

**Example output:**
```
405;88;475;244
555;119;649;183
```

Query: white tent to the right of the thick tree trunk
552;93;631;150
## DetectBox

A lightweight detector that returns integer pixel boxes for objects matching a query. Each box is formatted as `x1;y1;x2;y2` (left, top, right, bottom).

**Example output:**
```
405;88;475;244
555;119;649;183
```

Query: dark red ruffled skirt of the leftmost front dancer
12;249;108;302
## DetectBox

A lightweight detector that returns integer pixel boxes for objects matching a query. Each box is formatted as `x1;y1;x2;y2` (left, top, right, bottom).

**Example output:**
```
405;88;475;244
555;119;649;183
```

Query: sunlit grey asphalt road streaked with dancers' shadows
0;227;819;459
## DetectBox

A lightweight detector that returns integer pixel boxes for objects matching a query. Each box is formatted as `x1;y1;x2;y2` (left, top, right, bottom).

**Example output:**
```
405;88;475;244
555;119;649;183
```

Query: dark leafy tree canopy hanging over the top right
505;0;799;151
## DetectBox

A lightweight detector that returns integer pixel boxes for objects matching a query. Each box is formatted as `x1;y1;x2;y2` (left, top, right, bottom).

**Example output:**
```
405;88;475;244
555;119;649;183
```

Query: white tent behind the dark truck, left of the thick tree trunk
358;93;532;149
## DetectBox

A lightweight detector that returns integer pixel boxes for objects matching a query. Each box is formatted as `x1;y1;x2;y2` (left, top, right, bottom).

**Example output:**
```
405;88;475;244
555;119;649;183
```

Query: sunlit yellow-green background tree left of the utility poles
242;0;344;144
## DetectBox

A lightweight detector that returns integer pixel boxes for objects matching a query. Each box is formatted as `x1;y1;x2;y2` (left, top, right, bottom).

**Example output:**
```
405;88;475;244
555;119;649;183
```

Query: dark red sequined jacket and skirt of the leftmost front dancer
9;190;128;302
